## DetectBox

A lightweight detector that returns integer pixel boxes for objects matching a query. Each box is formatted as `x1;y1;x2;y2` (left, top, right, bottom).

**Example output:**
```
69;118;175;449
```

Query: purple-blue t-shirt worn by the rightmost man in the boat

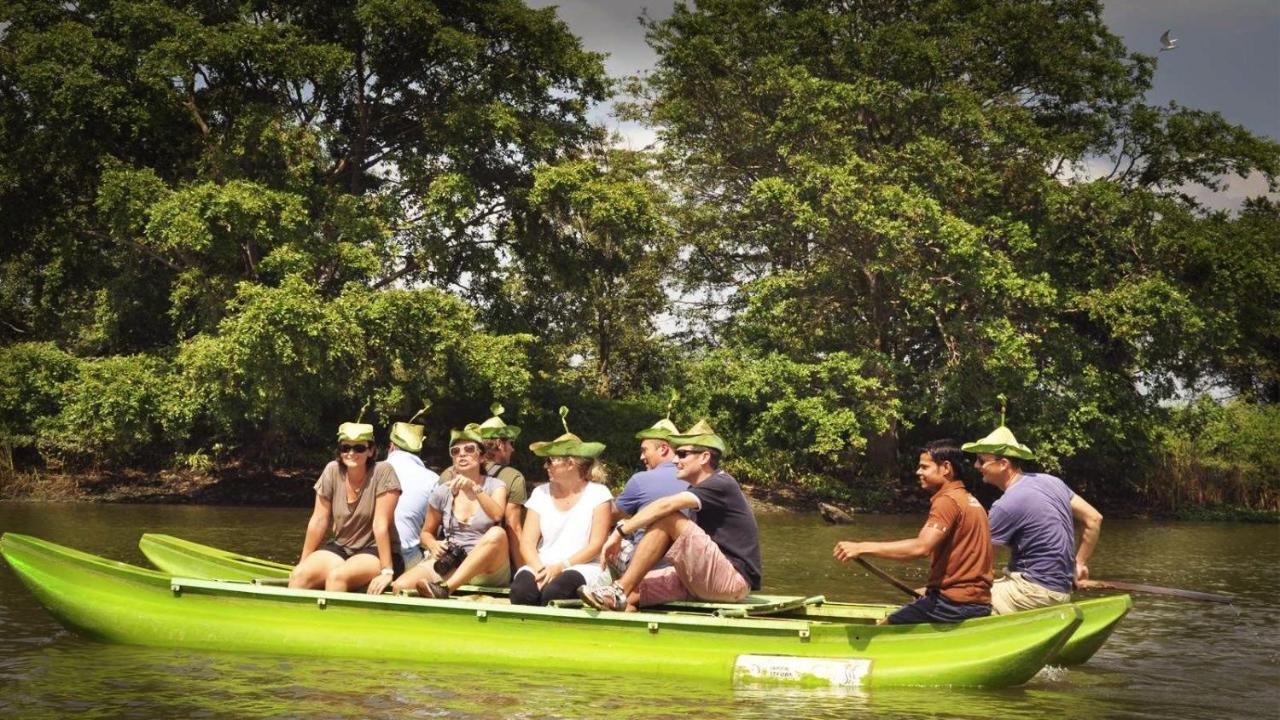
988;473;1075;592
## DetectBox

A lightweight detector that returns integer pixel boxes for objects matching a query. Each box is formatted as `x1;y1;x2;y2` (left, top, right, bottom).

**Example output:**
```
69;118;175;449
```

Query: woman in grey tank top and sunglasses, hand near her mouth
392;425;511;598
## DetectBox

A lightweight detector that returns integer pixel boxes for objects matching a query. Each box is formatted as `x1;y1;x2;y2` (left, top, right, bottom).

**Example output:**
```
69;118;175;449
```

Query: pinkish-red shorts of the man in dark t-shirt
636;523;751;606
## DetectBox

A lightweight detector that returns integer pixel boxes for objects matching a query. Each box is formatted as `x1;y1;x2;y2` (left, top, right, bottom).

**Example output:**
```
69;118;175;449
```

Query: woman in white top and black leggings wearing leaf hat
511;407;613;605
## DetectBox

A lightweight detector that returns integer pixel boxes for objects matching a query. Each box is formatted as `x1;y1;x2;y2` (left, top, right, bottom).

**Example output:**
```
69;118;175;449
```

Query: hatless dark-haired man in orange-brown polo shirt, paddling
832;439;995;625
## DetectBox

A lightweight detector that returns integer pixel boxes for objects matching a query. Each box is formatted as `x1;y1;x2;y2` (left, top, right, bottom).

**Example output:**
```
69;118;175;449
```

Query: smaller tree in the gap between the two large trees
517;150;675;397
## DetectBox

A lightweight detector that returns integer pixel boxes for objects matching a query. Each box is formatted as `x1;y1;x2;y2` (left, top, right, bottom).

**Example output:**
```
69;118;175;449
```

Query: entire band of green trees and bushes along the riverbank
0;0;1280;515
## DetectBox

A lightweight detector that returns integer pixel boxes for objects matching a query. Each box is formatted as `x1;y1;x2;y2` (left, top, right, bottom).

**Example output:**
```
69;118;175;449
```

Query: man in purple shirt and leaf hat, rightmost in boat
961;424;1102;615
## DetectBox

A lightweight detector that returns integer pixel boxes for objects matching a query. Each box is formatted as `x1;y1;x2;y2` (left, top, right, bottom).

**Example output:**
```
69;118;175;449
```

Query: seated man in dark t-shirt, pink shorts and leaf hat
579;420;763;610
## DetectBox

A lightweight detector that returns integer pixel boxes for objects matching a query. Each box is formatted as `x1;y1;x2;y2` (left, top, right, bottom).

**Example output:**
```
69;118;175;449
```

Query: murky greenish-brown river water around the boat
0;502;1280;720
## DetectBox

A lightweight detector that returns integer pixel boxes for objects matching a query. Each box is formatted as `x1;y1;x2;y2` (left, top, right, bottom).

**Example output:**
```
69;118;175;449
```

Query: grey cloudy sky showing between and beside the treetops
529;0;1280;209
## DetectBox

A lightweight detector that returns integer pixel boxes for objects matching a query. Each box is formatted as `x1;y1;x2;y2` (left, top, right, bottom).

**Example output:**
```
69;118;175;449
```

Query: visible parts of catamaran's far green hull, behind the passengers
138;533;1133;666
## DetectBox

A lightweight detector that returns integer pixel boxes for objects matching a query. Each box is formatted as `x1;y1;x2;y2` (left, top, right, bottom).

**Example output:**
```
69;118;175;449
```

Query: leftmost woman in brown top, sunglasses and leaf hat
289;423;403;594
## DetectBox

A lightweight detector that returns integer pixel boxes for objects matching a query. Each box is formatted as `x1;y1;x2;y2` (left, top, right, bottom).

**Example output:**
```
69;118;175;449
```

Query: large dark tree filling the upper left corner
0;0;608;354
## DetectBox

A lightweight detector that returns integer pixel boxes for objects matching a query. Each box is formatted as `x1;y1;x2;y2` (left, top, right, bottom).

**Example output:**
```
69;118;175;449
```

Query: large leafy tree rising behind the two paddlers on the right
634;0;1280;484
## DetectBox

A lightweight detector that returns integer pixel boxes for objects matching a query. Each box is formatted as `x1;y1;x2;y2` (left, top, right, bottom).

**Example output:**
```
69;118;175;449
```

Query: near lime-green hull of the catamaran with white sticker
0;533;1082;688
